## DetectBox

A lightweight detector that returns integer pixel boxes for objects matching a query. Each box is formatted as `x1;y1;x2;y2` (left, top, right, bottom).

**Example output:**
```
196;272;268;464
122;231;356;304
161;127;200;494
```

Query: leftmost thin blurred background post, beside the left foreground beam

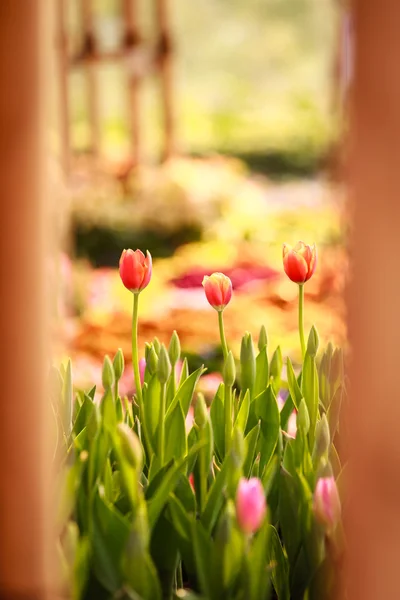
56;0;71;176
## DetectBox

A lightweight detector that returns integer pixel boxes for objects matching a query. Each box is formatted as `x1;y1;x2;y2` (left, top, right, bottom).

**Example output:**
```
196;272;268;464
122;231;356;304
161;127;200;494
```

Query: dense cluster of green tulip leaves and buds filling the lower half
51;328;345;600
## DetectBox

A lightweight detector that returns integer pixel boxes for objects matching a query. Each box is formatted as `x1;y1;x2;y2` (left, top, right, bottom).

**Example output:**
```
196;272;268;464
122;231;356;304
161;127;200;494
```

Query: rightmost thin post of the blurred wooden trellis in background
155;0;175;160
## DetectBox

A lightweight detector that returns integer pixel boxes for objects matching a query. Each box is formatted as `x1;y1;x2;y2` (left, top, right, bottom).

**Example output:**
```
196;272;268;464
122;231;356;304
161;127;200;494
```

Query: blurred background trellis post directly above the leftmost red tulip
123;0;142;166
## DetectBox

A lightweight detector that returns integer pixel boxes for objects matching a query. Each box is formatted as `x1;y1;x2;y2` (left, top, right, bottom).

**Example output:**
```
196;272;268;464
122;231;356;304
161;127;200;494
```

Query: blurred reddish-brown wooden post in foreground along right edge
341;0;400;600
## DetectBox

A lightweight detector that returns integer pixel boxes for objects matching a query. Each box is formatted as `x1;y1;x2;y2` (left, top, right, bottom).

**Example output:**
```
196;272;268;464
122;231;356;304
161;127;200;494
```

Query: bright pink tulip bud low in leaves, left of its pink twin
236;477;267;534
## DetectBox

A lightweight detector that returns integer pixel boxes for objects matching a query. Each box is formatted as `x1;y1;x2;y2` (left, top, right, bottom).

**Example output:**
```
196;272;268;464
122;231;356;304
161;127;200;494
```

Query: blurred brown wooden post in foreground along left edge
0;0;53;600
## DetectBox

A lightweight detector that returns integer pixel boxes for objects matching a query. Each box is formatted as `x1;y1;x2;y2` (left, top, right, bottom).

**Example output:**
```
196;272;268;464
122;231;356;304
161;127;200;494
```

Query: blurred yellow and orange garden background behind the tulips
50;0;347;392
